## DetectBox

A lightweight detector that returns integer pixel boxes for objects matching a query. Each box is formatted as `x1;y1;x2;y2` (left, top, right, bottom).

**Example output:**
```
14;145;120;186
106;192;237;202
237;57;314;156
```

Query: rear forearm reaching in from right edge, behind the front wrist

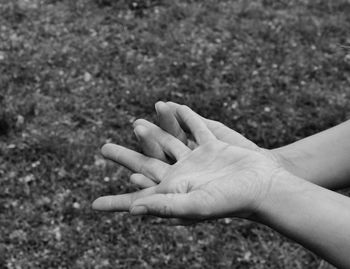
273;121;350;189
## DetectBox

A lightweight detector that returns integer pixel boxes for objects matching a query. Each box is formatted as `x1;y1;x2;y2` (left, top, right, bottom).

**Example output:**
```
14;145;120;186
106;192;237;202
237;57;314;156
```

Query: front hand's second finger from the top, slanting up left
134;120;191;160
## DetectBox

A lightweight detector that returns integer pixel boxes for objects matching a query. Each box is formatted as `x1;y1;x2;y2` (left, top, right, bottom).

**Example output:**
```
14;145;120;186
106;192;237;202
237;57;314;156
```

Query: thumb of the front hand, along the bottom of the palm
130;193;205;219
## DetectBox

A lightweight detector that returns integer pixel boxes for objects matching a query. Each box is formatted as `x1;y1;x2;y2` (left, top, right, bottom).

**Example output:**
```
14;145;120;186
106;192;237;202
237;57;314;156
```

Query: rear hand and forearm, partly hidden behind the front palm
134;102;350;189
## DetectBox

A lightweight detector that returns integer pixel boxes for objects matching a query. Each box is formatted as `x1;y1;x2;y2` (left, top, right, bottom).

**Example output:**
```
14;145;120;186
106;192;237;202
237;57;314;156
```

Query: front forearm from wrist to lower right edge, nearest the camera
260;173;350;268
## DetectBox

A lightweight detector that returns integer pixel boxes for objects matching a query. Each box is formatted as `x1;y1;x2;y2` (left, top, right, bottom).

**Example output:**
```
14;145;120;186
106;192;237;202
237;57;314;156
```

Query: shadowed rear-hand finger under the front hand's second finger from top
134;119;168;162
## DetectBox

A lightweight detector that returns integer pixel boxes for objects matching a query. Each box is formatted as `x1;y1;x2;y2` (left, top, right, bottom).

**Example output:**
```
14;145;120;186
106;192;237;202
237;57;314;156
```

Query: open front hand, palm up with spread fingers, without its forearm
93;106;288;220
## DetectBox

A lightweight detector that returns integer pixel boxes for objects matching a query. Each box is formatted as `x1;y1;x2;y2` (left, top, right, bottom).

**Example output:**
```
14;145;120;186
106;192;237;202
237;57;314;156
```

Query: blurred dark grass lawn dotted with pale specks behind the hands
0;0;350;269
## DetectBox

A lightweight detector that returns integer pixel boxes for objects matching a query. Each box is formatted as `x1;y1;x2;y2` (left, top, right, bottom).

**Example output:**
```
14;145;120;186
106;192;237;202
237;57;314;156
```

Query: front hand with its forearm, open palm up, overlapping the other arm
93;102;350;268
